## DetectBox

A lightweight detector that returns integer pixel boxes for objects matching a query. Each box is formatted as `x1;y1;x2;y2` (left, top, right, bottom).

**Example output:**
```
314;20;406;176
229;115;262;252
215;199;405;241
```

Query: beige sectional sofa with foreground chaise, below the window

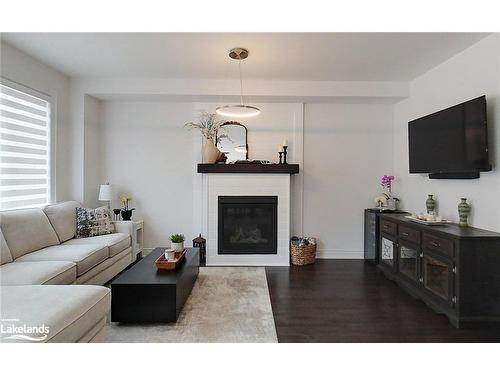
0;201;136;342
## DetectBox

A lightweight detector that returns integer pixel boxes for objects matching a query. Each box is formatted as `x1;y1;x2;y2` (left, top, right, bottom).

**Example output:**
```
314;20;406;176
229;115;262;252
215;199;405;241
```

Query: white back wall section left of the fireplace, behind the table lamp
100;102;195;247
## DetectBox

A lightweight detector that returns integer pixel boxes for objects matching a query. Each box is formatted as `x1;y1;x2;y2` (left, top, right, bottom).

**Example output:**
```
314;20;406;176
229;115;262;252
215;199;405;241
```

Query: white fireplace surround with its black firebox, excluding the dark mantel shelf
201;173;291;267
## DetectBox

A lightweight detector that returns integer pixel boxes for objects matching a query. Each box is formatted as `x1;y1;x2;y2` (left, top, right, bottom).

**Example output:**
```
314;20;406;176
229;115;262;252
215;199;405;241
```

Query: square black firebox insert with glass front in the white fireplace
217;196;278;254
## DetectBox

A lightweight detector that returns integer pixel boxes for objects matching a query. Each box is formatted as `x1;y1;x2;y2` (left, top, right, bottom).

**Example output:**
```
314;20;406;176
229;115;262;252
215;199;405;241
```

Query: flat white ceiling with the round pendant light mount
1;33;488;81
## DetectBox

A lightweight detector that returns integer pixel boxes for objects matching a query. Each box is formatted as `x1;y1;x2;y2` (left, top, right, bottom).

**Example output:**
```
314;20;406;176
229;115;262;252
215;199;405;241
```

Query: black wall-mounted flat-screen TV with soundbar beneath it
408;96;491;178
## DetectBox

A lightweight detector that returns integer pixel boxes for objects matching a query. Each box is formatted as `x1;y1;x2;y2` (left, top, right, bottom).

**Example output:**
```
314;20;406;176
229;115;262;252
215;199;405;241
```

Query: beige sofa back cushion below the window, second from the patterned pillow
0;208;59;259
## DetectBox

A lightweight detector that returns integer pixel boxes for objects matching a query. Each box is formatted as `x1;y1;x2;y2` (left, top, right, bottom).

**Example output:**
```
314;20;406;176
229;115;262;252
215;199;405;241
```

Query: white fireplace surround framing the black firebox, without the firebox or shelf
202;173;290;266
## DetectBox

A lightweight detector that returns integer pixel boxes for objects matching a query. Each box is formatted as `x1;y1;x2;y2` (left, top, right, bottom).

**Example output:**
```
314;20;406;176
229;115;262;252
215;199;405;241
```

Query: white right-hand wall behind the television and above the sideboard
394;34;500;231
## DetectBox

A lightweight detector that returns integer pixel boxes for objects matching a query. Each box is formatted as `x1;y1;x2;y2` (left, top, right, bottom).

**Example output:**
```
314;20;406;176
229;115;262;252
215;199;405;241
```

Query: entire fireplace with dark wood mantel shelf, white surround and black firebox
198;164;299;266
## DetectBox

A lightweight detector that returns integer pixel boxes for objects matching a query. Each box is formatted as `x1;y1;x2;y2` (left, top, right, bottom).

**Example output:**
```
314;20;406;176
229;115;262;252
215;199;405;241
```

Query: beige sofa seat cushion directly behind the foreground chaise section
0;261;76;286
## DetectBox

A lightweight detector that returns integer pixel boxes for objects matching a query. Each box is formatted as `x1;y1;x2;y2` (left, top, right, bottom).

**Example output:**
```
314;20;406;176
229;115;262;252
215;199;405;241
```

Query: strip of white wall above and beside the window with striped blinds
0;41;71;201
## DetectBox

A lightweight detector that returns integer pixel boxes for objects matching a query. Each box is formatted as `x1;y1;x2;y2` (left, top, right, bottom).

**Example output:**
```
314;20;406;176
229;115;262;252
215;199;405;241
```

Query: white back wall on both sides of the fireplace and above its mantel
95;101;392;258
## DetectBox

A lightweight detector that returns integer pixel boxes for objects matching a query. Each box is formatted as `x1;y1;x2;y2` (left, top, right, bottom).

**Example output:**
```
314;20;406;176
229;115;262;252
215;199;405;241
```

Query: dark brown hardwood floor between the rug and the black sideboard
266;260;500;342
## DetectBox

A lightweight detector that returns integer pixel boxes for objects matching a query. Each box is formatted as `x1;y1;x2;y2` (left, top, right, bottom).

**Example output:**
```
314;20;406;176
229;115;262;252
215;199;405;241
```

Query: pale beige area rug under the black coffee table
107;267;277;343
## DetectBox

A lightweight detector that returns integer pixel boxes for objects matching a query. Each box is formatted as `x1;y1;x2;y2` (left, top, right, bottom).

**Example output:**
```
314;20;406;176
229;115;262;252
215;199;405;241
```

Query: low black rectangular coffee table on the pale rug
111;247;200;323
